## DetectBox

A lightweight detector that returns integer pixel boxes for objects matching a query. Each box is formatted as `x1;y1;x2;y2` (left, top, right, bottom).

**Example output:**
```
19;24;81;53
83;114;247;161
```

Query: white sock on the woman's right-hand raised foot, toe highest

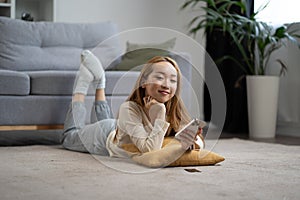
81;50;105;89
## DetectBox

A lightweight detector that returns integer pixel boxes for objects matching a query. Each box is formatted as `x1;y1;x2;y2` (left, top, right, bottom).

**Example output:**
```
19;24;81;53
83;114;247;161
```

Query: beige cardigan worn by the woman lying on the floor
106;101;170;157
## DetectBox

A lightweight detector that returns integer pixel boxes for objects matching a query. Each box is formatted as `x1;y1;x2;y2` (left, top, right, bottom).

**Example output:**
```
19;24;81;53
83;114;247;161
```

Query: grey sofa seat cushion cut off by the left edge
0;70;30;95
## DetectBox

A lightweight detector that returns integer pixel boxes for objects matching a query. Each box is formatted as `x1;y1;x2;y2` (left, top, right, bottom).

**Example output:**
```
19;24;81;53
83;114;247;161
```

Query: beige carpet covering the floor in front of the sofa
0;139;300;200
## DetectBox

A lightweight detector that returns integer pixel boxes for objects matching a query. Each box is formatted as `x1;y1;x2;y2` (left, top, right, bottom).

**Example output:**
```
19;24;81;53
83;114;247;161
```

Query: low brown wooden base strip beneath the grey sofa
0;125;64;131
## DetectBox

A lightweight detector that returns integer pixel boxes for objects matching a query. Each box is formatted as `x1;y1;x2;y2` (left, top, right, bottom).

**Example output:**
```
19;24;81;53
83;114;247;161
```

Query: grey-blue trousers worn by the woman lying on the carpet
62;101;116;156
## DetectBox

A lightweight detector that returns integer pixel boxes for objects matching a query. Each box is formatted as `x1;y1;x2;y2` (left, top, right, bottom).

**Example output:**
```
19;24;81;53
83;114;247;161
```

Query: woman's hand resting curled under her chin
143;96;166;124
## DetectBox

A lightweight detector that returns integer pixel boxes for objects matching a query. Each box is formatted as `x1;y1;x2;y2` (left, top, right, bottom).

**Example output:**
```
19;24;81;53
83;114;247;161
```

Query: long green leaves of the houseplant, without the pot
181;0;300;75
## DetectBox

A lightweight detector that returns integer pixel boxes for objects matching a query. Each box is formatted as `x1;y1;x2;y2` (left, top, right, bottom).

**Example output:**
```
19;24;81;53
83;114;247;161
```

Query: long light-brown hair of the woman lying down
127;56;191;136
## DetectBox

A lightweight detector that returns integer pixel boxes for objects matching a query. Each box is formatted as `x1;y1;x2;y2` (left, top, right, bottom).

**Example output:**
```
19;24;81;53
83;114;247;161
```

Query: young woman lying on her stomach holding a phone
62;50;202;166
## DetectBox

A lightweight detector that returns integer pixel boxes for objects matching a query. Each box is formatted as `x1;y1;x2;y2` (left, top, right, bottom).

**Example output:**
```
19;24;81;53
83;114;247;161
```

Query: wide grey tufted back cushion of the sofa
0;17;121;71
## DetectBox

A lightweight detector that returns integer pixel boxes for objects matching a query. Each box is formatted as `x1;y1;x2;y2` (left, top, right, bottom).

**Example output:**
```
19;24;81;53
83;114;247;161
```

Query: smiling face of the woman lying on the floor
143;62;177;103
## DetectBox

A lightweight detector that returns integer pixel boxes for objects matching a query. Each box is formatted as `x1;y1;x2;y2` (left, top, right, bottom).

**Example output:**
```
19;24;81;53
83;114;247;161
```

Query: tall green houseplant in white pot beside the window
181;0;299;138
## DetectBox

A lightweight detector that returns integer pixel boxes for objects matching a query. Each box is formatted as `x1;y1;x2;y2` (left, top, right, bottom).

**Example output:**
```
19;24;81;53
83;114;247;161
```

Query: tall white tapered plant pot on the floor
246;76;279;139
